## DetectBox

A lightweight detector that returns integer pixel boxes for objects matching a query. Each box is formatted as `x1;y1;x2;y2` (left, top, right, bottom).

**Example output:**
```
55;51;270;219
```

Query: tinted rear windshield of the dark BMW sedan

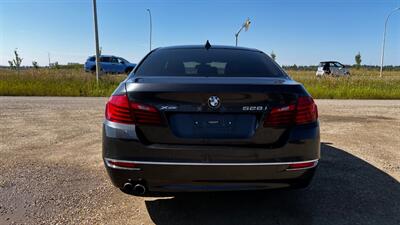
135;48;286;77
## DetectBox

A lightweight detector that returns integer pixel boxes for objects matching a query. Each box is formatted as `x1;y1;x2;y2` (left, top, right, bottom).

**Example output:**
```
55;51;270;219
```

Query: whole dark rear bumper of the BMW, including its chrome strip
103;121;320;192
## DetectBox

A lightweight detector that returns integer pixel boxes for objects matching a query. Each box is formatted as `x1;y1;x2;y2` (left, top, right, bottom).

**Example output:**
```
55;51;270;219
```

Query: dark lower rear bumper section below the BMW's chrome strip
105;158;318;192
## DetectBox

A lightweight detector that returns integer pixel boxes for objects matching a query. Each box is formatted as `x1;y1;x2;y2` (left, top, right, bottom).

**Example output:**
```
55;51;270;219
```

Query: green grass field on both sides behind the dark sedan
0;68;400;99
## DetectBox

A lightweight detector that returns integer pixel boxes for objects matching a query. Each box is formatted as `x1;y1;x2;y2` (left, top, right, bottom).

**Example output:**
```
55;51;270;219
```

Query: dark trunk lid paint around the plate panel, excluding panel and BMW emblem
126;77;306;144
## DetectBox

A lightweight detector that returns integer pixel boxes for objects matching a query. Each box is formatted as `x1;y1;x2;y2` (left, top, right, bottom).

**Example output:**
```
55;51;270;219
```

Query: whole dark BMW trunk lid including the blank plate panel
126;77;304;145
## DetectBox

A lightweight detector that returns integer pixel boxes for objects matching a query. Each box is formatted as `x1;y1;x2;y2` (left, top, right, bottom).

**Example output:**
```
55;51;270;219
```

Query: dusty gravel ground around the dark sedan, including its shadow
0;97;400;225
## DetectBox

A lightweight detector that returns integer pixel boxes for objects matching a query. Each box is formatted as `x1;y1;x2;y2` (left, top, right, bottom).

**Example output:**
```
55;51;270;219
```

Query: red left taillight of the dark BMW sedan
105;94;161;125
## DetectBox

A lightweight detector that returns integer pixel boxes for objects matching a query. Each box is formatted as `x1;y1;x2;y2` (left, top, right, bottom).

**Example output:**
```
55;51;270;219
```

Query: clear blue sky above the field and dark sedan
0;0;400;65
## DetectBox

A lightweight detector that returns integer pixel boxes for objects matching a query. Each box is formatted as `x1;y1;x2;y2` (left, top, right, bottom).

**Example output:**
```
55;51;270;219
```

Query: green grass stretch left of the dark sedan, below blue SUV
0;68;126;96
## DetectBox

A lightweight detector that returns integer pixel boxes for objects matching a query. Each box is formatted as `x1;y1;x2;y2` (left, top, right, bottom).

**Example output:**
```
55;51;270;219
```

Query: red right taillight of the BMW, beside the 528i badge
264;96;318;127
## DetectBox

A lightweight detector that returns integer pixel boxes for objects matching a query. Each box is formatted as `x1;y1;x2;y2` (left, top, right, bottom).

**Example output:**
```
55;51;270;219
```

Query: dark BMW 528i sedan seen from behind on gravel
103;45;320;196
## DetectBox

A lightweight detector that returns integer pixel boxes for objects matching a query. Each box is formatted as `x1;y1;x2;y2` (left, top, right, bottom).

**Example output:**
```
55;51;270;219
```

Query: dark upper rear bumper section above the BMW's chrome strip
103;124;320;163
